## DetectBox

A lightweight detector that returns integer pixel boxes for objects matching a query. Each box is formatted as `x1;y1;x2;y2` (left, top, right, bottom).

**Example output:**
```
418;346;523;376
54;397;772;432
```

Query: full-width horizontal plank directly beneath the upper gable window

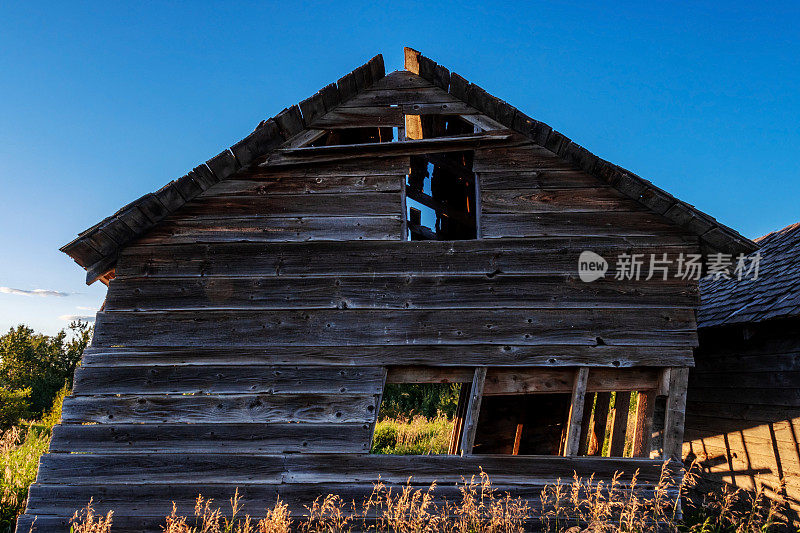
116;235;699;279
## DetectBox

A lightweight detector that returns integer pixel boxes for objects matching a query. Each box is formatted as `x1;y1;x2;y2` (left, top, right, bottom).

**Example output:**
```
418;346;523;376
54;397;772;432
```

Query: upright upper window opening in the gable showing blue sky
405;151;478;241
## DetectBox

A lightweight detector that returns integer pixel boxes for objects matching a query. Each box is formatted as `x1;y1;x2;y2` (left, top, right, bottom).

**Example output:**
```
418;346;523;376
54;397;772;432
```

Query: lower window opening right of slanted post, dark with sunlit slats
472;368;664;457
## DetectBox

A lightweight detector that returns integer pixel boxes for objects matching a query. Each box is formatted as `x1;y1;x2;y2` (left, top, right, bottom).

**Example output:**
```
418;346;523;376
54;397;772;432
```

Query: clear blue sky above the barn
0;1;800;333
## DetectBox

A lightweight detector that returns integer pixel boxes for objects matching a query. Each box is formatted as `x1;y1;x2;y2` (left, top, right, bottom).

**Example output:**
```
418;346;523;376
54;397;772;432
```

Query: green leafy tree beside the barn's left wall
0;322;92;428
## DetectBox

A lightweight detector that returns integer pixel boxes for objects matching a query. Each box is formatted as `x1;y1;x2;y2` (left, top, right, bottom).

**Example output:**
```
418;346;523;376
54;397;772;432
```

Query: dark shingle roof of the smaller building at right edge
697;222;800;327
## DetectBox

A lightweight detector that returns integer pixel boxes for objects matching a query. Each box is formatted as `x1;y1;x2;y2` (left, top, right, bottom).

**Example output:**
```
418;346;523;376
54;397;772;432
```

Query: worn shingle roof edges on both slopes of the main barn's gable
61;48;755;283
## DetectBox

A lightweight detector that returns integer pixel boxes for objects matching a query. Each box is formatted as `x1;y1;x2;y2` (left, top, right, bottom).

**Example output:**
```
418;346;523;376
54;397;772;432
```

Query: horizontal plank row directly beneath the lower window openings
34;453;661;485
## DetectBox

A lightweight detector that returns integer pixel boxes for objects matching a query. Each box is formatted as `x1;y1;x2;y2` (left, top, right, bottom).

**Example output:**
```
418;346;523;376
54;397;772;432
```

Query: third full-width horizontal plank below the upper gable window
93;309;697;346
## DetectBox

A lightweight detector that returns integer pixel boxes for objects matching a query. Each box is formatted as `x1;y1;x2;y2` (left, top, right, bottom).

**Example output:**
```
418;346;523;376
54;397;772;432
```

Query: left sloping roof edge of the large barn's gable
60;54;385;285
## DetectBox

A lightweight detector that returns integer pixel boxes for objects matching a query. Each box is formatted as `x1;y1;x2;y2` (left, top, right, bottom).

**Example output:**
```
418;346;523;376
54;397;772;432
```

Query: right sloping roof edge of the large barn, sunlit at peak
404;47;758;253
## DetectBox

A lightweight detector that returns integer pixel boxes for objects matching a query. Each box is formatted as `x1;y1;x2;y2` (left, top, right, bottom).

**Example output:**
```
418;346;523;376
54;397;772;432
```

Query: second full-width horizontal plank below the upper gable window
105;274;699;311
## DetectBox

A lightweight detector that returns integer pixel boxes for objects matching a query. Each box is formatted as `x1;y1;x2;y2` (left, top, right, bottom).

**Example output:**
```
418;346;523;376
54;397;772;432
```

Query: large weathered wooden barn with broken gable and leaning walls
18;49;755;532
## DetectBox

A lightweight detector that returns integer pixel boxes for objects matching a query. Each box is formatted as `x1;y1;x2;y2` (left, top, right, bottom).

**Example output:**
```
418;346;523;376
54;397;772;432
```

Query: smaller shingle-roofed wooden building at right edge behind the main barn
684;220;800;521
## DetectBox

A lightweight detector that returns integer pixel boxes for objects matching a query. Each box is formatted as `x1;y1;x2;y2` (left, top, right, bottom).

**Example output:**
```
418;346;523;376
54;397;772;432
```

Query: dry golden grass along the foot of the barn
64;465;780;533
